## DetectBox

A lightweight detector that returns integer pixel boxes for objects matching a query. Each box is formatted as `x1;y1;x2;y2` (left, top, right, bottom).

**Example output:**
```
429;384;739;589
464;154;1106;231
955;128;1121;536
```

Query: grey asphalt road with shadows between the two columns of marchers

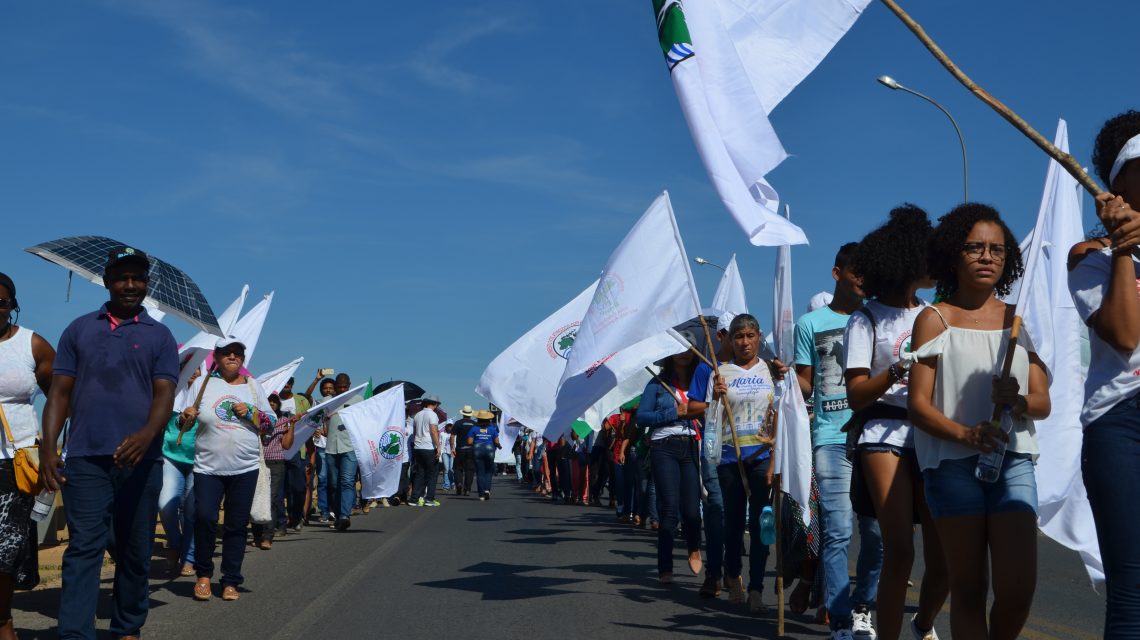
14;478;1104;640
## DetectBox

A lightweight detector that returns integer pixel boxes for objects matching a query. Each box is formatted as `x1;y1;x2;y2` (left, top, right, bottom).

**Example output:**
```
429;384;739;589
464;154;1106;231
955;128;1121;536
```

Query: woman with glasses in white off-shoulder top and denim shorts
907;203;1050;639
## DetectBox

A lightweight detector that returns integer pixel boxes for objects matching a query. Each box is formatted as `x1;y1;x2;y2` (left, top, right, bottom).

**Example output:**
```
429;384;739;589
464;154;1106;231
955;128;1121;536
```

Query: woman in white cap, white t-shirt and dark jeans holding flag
181;338;277;600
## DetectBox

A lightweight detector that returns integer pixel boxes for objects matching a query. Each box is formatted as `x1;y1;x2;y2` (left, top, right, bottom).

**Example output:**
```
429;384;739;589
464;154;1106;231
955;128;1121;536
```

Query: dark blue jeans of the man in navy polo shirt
59;455;162;639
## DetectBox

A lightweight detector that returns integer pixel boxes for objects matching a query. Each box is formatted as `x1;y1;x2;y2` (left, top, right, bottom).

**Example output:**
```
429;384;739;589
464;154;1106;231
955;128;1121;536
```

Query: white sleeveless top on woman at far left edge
0;326;40;460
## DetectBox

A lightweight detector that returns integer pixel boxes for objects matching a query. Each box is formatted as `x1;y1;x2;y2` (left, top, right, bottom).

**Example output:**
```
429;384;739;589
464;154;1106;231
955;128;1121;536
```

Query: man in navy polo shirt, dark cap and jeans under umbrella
40;246;178;639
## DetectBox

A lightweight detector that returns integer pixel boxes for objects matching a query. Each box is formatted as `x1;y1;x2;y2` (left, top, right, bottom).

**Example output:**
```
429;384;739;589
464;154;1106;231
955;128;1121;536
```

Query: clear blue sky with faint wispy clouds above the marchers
0;0;1140;412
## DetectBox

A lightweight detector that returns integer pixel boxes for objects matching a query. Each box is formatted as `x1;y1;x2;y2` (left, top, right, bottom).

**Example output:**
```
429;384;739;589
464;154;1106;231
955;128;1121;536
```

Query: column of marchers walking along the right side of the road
519;112;1140;640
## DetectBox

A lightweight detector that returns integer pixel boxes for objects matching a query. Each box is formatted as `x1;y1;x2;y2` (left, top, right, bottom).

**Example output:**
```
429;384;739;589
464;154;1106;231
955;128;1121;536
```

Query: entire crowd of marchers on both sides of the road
0;112;1140;640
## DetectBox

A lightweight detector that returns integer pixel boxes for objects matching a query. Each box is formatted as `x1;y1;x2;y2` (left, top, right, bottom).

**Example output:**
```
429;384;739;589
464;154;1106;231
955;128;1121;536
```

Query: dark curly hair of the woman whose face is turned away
852;203;934;298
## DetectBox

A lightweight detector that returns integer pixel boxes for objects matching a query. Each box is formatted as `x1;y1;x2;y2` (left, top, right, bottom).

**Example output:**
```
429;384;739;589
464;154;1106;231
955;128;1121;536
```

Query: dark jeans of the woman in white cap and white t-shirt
194;469;259;586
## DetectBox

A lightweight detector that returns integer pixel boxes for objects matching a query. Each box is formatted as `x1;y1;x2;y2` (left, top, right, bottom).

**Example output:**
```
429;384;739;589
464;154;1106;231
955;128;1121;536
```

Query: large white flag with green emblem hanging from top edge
653;0;870;246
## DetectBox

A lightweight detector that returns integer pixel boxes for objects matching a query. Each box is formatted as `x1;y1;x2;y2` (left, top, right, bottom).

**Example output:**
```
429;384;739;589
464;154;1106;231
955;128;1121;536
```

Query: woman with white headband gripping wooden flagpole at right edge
1069;111;1140;638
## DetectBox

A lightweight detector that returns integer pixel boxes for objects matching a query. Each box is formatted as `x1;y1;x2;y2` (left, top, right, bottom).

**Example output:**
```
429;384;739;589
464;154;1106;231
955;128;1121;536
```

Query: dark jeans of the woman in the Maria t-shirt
716;459;772;592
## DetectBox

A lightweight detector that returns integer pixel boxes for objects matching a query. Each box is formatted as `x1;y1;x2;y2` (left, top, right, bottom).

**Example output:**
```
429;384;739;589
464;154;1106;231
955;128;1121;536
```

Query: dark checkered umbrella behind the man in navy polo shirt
24;235;221;335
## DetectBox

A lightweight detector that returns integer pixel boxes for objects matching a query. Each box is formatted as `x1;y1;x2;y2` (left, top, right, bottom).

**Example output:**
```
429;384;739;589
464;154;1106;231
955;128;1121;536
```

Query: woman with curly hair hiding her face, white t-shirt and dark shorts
844;204;950;639
